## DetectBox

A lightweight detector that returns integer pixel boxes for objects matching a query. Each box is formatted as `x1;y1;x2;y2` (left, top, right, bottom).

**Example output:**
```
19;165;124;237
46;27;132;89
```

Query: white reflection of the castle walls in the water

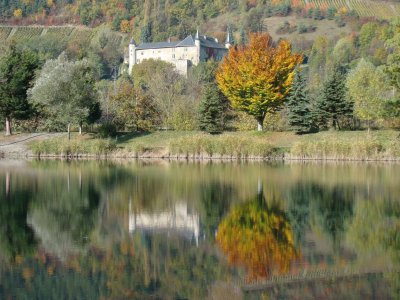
129;203;200;244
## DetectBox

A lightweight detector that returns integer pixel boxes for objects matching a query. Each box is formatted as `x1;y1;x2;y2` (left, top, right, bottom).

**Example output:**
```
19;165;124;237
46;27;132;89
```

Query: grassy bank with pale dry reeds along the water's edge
0;130;400;161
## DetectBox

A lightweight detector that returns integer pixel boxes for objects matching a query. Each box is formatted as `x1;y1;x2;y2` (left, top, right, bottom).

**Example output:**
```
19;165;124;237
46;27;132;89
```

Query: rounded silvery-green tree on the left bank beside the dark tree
29;55;99;136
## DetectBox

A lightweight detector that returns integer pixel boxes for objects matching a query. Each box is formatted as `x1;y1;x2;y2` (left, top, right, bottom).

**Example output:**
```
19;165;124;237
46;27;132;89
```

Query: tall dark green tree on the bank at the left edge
0;45;39;135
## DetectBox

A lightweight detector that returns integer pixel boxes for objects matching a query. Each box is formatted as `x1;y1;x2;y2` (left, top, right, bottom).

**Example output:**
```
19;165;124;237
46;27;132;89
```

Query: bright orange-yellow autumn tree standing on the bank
216;33;303;131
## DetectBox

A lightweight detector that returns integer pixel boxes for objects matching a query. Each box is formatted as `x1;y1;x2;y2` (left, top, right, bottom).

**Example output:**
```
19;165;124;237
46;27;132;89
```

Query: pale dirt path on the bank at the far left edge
0;133;65;157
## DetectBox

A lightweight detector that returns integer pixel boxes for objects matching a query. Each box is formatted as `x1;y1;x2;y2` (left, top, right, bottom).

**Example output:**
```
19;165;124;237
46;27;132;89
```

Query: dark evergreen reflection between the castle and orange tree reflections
200;182;235;240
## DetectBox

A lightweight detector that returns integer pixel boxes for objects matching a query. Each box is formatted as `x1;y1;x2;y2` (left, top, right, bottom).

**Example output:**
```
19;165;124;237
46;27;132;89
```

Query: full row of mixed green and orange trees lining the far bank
0;20;400;136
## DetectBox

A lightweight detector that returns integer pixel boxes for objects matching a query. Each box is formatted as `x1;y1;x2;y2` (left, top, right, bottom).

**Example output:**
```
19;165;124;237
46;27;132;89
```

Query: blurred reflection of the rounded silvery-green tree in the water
28;180;100;259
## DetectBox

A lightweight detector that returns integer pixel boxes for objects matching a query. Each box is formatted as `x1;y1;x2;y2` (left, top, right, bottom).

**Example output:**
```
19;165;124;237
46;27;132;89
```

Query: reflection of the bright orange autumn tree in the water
217;197;299;280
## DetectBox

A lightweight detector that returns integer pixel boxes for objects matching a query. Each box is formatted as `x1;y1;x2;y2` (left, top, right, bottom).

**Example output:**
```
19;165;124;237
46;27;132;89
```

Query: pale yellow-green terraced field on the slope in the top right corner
303;0;400;19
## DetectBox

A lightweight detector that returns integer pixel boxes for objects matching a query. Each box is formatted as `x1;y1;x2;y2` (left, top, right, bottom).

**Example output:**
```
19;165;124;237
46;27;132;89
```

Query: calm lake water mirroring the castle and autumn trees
0;161;400;300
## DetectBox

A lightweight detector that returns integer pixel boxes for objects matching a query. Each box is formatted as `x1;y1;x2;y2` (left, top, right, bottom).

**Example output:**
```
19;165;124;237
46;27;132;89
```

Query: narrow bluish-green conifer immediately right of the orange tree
288;71;315;134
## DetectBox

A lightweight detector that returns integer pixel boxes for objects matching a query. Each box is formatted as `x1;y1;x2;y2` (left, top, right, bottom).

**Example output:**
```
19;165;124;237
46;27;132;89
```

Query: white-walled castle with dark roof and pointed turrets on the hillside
129;31;232;75
